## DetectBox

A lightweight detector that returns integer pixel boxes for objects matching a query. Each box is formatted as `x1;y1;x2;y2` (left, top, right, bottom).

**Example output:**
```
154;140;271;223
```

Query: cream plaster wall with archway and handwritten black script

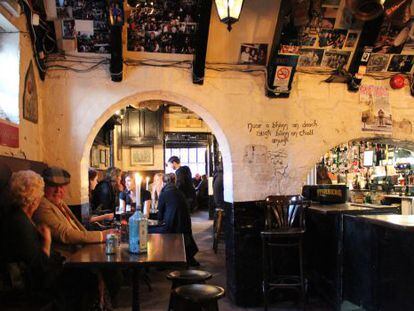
44;67;414;204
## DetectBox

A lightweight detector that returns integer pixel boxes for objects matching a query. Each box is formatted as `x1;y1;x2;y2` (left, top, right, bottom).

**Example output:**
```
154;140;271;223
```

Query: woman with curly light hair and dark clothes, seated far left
0;170;98;310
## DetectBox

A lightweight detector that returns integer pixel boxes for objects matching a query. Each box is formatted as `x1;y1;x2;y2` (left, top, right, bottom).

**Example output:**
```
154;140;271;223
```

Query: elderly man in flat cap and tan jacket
33;167;113;244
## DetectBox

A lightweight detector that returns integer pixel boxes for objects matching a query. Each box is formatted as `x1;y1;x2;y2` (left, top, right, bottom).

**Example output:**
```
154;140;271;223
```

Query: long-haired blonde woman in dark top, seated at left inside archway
92;167;124;213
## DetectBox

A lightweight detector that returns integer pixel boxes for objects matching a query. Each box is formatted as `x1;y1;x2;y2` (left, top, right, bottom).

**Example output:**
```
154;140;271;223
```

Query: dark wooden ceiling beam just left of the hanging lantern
193;0;213;84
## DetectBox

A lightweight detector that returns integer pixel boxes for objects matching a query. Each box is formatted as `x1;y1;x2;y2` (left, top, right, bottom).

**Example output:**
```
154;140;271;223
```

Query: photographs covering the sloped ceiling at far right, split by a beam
279;0;414;73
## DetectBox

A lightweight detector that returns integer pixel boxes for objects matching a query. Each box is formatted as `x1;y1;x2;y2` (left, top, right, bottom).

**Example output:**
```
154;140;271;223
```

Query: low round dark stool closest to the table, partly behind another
167;270;213;310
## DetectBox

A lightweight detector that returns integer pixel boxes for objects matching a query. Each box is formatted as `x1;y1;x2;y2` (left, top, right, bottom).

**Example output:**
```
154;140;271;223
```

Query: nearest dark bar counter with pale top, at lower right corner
342;215;414;310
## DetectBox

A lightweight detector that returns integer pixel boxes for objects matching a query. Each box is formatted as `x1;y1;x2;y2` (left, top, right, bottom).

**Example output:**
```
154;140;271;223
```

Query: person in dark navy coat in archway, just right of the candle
149;174;200;266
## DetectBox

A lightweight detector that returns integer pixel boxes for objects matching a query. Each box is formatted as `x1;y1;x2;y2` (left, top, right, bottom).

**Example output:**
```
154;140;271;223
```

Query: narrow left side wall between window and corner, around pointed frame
0;7;43;161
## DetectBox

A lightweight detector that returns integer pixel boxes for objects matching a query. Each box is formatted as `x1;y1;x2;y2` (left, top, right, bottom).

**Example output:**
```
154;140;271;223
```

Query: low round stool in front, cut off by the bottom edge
174;284;225;311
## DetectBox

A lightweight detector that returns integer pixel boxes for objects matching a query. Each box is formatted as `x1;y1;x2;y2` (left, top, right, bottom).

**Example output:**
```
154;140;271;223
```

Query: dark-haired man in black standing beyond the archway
168;156;196;210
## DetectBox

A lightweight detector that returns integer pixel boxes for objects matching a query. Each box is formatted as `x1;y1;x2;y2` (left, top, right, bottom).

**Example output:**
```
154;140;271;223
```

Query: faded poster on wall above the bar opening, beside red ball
359;85;392;134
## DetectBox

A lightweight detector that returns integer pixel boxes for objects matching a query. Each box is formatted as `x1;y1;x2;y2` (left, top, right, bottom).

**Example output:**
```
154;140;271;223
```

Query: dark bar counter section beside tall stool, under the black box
305;203;400;310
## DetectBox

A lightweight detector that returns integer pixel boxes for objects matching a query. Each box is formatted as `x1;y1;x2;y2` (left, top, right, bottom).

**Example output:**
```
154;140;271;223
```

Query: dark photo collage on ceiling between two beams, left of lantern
127;0;197;54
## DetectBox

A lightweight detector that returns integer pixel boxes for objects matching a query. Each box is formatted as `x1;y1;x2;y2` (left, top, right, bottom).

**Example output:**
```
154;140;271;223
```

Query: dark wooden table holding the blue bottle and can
65;234;186;310
